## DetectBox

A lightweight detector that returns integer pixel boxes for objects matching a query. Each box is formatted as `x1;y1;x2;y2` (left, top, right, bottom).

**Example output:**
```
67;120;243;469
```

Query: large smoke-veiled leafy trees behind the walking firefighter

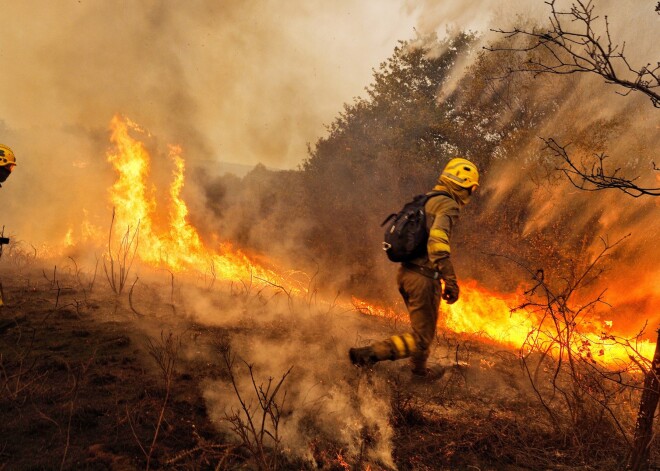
200;25;648;299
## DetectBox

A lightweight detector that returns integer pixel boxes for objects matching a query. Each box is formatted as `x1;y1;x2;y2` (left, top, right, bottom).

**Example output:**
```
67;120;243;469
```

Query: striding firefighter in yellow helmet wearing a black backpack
349;157;479;376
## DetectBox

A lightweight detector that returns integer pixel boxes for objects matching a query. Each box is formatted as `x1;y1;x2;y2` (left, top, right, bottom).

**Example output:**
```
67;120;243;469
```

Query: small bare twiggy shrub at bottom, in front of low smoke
221;346;293;470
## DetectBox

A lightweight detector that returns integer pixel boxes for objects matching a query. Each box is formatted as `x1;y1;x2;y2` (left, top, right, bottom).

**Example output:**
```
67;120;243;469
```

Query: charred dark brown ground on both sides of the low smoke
0;264;657;470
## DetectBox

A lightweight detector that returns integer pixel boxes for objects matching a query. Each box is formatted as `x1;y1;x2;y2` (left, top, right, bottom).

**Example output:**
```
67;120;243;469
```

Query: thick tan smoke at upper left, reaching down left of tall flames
0;1;413;244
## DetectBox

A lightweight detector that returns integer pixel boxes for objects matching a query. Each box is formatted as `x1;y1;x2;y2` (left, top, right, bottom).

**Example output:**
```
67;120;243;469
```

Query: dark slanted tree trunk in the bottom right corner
628;330;660;471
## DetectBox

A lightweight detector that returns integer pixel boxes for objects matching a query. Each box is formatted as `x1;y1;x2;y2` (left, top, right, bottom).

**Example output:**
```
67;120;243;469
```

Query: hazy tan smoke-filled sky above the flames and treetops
0;0;655;168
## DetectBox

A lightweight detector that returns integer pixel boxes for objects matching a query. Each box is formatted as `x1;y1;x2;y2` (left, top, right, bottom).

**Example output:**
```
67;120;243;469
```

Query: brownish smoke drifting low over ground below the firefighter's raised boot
171;286;393;467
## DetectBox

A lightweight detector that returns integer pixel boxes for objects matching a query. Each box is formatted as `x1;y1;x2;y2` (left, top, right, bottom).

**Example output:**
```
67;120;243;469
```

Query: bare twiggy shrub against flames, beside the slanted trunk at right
496;237;648;464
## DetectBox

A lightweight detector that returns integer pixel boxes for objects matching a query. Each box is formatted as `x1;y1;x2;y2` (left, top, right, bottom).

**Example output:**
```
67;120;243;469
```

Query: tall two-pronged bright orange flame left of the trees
107;116;298;291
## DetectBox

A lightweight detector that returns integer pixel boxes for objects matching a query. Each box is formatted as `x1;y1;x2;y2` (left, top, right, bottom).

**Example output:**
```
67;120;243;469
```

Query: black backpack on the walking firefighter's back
381;191;451;262
